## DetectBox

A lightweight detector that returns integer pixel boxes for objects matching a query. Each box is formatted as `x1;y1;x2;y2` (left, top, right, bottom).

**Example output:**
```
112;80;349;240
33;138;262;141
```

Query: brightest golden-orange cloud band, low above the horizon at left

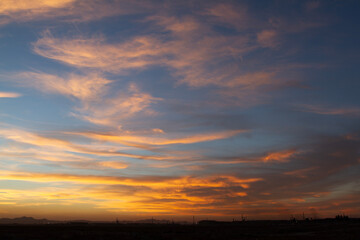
0;170;262;215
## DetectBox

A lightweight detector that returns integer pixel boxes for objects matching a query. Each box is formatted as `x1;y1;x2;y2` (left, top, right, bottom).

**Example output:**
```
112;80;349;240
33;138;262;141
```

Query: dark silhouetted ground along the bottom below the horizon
0;220;360;240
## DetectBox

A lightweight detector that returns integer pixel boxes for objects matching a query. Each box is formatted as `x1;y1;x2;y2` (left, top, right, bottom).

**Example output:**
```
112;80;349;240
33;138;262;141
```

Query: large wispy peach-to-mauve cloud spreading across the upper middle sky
26;3;324;116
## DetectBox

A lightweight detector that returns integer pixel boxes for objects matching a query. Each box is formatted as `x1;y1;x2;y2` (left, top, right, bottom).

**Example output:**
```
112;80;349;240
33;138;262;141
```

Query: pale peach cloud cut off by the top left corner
0;0;153;25
